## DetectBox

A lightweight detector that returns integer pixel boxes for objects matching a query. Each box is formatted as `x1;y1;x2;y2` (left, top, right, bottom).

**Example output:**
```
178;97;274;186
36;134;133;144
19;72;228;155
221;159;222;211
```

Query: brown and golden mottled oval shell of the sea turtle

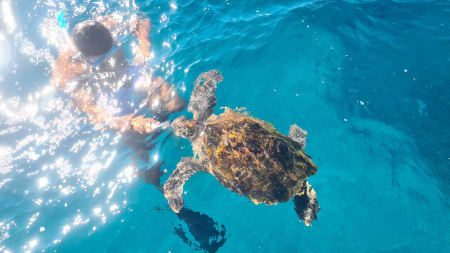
194;108;317;204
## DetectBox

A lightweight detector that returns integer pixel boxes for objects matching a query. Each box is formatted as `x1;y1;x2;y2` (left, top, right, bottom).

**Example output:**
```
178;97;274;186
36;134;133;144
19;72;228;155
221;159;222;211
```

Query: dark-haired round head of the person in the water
72;20;113;56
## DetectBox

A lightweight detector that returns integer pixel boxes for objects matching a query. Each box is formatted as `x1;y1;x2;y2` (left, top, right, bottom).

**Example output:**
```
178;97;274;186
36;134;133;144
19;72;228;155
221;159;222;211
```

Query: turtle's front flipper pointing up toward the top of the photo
188;70;223;122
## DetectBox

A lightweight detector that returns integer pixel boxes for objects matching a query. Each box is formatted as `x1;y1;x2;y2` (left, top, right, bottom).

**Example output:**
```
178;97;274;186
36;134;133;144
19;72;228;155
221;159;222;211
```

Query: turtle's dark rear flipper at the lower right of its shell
294;181;320;226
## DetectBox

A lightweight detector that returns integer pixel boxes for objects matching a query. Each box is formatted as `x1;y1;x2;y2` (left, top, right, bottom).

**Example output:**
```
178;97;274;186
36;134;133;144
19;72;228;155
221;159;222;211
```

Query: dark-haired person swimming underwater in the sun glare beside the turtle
52;16;186;134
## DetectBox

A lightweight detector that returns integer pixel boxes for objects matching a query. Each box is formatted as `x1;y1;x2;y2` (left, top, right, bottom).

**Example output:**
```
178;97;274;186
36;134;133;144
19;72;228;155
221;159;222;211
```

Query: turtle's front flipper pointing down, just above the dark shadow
164;157;201;213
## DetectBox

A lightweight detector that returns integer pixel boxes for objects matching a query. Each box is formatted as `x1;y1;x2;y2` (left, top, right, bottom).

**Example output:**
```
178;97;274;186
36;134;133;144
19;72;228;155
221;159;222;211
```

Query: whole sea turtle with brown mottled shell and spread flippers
164;70;319;226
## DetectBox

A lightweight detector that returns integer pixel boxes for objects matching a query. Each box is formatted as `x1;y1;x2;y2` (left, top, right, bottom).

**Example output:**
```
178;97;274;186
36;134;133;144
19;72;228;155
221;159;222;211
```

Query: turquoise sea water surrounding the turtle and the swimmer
0;0;450;252
